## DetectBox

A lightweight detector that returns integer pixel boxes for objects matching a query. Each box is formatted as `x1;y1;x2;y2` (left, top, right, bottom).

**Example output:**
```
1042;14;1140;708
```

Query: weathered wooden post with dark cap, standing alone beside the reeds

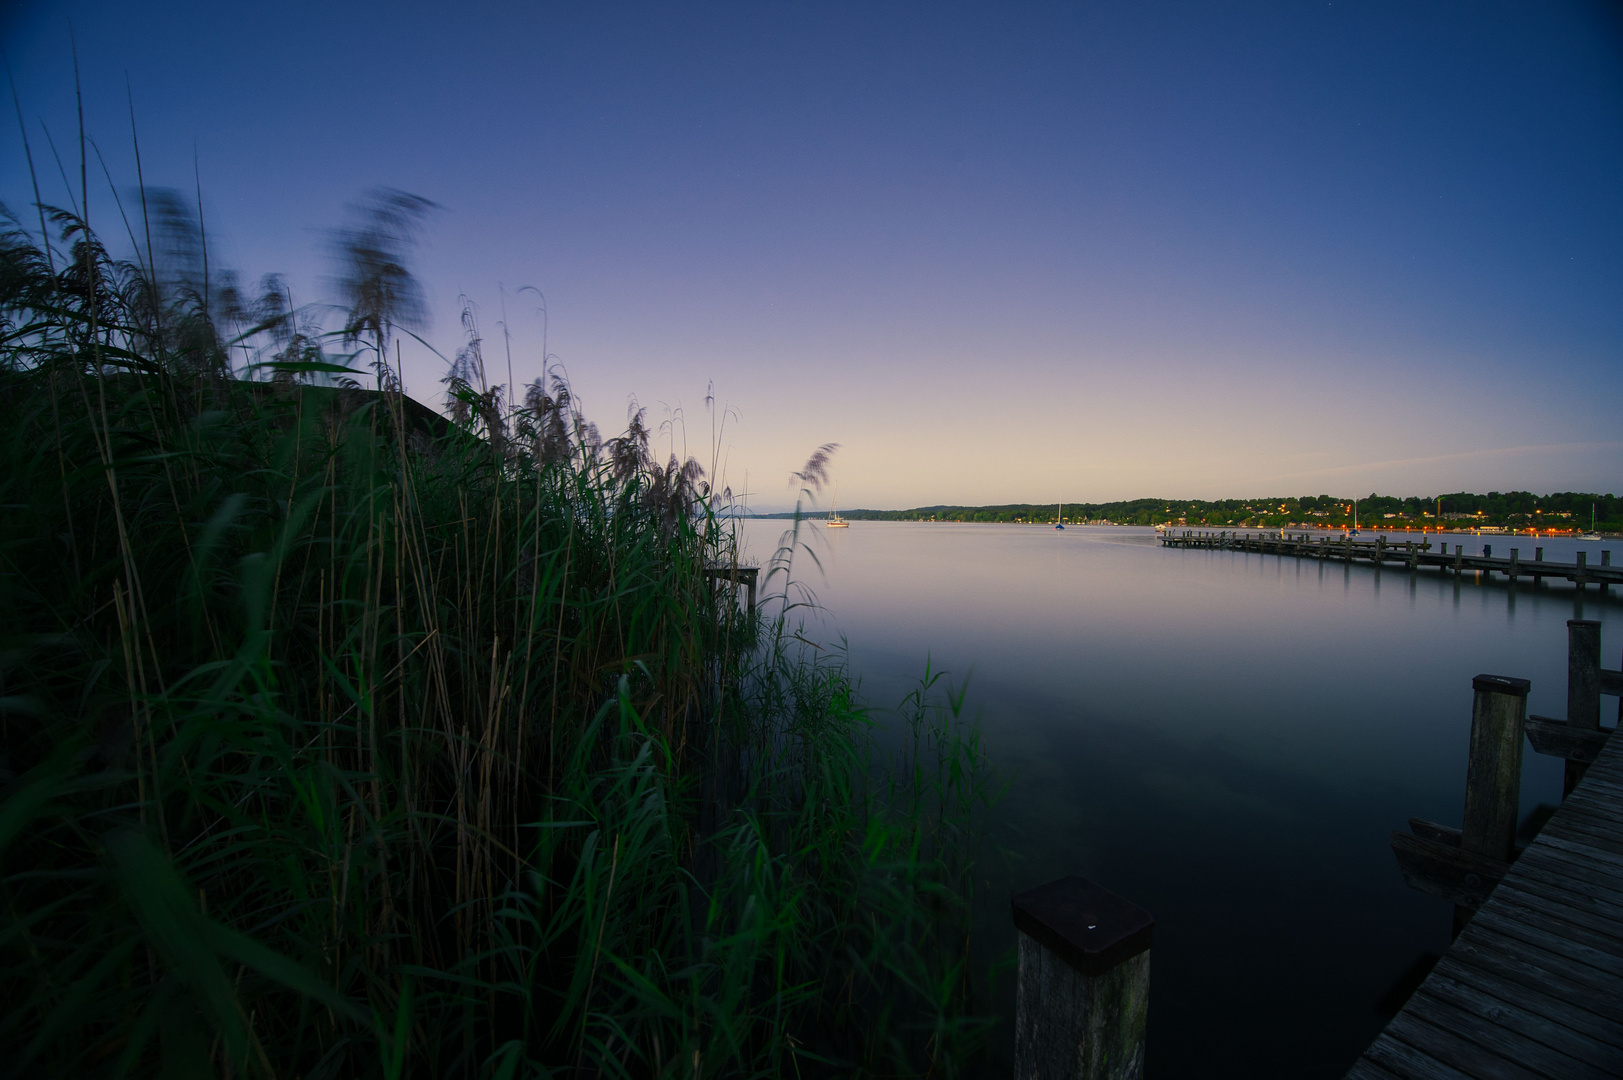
1013;877;1156;1080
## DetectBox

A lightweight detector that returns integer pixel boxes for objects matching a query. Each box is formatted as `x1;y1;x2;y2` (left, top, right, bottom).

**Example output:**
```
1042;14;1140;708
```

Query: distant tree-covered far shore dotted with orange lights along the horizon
775;492;1623;533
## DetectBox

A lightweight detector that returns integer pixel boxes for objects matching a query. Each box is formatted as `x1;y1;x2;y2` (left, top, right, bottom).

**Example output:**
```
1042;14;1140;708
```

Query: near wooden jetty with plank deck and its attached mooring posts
1347;619;1623;1080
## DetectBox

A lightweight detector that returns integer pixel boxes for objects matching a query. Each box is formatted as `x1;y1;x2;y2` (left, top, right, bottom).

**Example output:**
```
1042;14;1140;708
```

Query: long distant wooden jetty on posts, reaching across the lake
1160;529;1623;590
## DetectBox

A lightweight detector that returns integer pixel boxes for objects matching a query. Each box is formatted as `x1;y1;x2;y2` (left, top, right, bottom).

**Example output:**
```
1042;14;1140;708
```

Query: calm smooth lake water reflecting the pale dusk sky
745;521;1623;1078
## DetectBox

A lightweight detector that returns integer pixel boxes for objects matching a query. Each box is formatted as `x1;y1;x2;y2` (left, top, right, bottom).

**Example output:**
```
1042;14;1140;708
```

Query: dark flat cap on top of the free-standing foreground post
1013;877;1156;976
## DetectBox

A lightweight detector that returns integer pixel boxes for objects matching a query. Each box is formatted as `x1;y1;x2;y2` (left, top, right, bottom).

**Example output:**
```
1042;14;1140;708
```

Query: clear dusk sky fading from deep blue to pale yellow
0;0;1623;510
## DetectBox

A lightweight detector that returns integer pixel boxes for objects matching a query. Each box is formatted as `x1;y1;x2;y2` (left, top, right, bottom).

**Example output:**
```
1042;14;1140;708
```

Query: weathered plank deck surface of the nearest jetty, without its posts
1347;724;1623;1080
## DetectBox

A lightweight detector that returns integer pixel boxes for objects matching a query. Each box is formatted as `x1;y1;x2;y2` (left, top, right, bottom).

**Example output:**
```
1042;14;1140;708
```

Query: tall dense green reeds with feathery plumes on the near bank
0;192;992;1080
